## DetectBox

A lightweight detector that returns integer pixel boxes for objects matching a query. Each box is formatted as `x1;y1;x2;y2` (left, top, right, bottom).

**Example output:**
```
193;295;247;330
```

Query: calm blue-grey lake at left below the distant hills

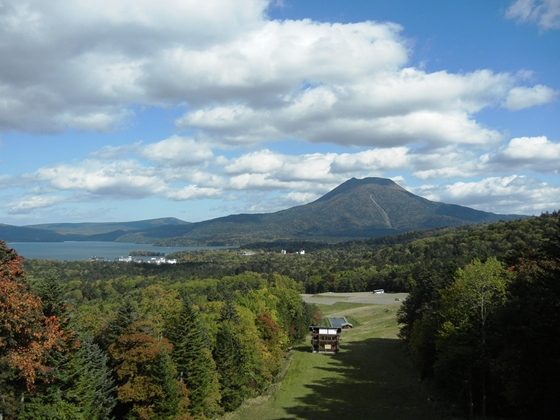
7;241;229;261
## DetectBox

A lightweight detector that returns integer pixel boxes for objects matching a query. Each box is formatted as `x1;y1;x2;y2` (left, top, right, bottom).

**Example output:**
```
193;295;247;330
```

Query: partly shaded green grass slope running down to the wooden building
227;303;448;420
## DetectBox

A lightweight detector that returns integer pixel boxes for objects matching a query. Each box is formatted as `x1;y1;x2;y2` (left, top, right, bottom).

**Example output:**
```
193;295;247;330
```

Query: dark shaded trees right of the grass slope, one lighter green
399;213;560;419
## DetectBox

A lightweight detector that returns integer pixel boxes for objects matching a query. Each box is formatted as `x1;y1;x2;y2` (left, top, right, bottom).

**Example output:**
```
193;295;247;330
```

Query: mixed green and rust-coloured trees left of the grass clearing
0;242;316;420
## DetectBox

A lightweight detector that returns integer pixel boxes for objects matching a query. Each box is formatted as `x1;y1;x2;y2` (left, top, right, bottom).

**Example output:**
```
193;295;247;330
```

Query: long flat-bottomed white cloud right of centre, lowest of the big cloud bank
177;69;513;148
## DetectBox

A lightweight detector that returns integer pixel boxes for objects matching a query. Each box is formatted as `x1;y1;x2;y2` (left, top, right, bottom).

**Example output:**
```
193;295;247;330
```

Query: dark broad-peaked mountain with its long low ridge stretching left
0;178;525;246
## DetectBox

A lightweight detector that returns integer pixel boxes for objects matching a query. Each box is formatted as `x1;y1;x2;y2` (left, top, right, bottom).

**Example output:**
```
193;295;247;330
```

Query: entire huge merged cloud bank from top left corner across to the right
0;0;554;152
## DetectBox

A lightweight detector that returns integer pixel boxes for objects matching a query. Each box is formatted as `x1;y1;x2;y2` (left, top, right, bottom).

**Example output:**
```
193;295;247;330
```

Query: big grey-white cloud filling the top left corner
0;0;267;132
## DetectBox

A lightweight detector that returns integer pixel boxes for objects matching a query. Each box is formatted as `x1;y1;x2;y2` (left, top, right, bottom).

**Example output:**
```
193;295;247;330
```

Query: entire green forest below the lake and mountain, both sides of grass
0;213;560;419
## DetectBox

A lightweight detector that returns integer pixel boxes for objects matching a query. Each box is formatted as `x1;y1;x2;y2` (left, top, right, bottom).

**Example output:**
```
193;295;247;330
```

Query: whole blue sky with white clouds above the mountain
0;0;560;226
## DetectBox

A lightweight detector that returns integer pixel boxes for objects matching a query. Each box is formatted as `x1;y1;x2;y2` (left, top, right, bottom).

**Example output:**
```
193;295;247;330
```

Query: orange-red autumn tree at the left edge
0;241;64;416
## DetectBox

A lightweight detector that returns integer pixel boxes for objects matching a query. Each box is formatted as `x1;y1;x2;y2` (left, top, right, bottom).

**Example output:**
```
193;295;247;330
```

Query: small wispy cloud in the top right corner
506;0;560;30
